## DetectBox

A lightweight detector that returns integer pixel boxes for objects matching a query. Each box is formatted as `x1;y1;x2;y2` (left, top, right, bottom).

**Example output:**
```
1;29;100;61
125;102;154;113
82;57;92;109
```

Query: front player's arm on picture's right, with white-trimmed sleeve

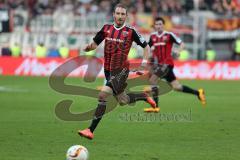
133;29;150;67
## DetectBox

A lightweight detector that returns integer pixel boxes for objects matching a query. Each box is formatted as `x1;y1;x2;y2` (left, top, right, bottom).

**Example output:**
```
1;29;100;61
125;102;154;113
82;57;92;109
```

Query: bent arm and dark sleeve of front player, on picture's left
83;25;105;52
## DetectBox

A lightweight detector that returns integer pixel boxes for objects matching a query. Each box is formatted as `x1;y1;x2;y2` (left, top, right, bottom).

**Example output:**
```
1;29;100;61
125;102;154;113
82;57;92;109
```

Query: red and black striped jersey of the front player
93;24;147;71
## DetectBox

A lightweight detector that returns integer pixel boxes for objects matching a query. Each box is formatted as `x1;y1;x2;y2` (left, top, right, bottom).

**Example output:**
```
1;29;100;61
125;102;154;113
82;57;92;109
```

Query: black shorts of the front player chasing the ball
104;68;129;95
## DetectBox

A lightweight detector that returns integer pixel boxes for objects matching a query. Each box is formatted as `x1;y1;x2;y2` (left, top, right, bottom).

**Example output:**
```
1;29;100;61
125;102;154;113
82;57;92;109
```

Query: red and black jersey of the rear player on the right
148;31;182;66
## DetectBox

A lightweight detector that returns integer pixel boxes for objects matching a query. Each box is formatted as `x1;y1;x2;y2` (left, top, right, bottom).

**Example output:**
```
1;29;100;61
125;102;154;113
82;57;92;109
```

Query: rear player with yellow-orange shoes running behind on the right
144;17;206;112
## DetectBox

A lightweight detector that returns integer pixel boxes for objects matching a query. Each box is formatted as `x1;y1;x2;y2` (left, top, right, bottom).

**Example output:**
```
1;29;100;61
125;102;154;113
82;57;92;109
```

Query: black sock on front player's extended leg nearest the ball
89;100;106;132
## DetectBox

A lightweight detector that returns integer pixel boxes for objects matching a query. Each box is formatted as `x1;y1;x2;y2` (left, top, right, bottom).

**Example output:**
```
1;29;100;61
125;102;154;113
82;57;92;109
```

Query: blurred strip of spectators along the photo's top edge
0;0;240;17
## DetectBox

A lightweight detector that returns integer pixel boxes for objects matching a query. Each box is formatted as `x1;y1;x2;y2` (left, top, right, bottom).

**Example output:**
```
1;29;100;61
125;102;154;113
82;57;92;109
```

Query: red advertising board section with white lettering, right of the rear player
174;61;240;80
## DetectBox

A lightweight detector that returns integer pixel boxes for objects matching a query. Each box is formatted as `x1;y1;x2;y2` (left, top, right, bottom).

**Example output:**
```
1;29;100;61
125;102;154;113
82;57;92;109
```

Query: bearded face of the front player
113;7;127;26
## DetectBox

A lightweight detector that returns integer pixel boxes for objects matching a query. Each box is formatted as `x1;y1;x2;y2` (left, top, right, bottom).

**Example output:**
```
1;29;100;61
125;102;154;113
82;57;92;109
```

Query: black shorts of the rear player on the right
152;64;176;83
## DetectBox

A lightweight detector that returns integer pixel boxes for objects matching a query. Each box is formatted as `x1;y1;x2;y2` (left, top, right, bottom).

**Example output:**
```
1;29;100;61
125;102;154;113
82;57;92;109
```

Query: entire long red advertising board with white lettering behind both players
0;57;240;80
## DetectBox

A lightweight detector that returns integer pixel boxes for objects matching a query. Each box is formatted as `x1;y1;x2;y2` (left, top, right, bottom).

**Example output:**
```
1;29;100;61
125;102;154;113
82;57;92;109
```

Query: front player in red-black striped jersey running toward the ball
78;4;156;139
